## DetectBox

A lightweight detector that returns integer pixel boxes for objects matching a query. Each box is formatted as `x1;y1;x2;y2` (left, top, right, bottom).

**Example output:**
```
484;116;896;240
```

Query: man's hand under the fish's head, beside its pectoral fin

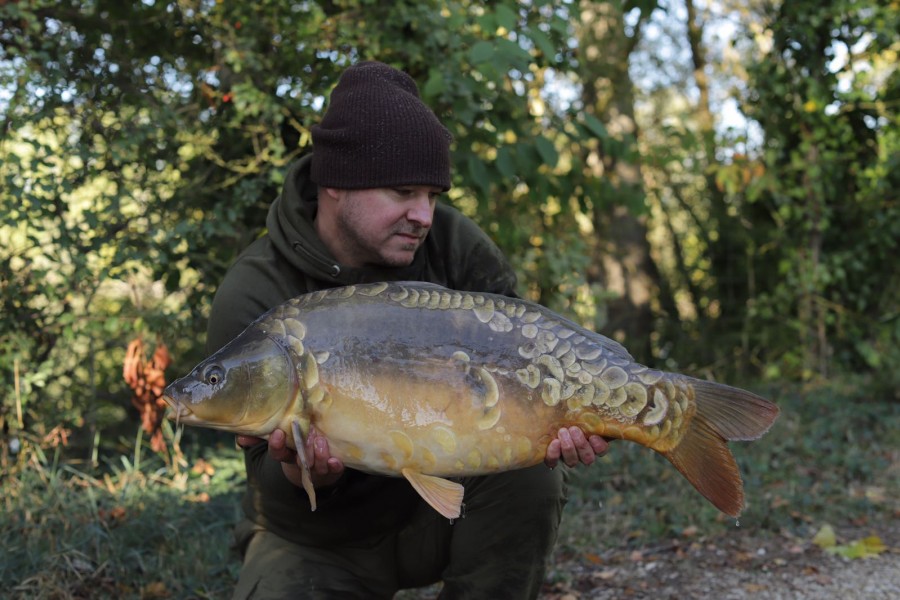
237;427;344;488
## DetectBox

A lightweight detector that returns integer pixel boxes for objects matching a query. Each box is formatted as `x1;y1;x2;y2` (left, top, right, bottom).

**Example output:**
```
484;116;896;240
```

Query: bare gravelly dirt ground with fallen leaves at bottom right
542;519;900;600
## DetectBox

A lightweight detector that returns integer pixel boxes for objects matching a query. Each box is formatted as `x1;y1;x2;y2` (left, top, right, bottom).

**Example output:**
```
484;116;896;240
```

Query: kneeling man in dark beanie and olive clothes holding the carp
208;62;606;599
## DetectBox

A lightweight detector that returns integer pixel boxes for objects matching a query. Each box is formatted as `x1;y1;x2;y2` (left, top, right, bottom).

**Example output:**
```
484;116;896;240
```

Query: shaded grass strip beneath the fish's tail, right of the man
558;385;900;555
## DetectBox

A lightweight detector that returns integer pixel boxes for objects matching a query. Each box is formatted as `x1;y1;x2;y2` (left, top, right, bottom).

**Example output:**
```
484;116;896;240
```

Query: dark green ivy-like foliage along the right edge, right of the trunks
746;2;900;388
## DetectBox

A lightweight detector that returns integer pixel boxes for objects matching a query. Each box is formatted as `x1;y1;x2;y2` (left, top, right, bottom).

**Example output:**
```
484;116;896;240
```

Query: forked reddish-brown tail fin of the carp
664;379;779;517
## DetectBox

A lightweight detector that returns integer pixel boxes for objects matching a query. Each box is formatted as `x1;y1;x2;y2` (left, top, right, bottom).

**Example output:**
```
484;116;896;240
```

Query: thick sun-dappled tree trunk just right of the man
577;1;659;361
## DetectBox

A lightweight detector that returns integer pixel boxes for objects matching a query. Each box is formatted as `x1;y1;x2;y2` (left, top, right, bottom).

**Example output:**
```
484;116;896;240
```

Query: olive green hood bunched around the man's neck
266;154;431;287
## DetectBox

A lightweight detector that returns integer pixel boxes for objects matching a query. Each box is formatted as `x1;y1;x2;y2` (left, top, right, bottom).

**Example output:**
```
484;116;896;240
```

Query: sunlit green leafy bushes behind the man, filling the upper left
0;0;612;458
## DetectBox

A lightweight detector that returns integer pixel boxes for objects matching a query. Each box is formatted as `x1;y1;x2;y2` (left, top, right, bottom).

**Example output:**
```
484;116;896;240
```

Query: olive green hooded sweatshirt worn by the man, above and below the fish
207;155;516;546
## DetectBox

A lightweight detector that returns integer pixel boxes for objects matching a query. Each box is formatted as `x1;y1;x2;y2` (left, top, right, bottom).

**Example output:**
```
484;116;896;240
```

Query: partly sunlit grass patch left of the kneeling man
0;434;244;599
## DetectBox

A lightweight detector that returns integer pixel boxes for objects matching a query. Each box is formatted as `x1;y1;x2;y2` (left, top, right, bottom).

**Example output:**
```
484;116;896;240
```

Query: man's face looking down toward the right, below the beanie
331;186;441;267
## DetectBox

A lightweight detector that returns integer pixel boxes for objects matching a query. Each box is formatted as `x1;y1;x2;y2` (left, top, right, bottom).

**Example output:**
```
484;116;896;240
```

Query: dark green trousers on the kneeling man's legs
234;465;565;600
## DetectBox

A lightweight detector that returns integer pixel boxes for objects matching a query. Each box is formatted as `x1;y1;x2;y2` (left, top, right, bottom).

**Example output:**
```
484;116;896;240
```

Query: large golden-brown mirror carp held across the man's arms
163;282;779;519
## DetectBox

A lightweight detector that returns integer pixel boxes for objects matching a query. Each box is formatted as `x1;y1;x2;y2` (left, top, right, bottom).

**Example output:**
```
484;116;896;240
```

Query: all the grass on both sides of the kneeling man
0;385;900;599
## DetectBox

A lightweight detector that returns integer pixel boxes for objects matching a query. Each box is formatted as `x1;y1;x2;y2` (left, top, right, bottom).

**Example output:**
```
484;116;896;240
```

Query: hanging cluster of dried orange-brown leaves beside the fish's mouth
122;336;172;452
